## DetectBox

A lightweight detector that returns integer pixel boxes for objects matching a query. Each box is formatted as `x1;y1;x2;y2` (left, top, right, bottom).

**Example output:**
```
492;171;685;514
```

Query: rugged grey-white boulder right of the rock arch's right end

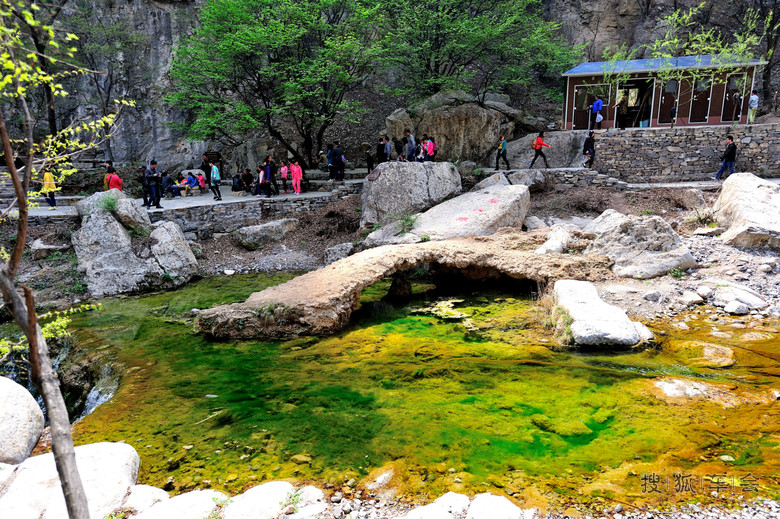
585;209;696;279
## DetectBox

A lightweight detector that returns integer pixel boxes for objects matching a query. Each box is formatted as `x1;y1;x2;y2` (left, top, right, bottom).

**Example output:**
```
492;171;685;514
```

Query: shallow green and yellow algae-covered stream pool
68;275;780;503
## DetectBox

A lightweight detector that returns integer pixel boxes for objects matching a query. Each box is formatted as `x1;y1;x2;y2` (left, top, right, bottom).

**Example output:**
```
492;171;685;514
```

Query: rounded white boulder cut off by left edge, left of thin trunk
0;377;43;465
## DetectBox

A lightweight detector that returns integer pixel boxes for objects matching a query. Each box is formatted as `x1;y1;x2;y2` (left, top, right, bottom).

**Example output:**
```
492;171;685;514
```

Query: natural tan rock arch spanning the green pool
198;229;611;339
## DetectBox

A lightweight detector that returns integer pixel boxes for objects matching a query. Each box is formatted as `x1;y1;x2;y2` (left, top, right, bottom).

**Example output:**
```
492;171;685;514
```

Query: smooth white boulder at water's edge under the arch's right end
553;279;642;346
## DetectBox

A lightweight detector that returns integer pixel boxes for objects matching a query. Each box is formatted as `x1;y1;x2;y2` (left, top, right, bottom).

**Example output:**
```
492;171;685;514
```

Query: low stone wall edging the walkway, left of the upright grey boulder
149;182;363;239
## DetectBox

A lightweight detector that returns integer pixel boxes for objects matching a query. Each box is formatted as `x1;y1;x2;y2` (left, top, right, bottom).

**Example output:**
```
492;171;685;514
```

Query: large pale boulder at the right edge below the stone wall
713;173;780;250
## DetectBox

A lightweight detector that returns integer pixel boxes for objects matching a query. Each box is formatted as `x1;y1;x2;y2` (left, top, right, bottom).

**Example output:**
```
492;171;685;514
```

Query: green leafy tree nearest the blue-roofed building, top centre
384;0;581;97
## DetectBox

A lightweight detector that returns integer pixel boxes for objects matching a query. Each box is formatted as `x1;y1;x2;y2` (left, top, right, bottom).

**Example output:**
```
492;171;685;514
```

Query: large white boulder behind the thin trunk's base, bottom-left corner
0;443;139;519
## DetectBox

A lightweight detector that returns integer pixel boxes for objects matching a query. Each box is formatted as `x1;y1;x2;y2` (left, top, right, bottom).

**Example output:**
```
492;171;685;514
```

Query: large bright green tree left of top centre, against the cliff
167;0;382;164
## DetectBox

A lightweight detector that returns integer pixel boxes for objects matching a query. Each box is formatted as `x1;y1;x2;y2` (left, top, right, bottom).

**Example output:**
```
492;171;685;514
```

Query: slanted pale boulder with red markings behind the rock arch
411;185;531;240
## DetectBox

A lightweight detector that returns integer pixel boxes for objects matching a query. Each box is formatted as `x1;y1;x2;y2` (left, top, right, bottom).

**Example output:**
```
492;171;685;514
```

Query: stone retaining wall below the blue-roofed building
596;124;780;183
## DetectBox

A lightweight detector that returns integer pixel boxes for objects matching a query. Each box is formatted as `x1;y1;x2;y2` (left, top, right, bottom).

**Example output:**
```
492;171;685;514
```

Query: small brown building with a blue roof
563;55;766;130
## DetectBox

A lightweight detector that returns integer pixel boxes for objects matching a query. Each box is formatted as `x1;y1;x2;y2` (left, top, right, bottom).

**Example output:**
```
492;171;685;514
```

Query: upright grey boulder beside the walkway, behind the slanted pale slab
360;162;461;227
